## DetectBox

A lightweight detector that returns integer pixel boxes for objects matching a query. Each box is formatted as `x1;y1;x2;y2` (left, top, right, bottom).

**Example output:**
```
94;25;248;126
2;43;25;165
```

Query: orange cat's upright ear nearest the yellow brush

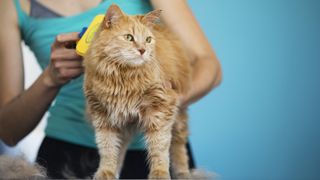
104;4;124;28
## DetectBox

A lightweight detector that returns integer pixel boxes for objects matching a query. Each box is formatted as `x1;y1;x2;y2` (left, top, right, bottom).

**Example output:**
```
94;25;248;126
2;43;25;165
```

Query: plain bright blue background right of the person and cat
189;0;320;180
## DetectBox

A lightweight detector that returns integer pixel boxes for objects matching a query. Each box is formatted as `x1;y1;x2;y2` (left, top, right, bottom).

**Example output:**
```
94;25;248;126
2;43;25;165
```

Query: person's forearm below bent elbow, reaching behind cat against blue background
182;57;222;107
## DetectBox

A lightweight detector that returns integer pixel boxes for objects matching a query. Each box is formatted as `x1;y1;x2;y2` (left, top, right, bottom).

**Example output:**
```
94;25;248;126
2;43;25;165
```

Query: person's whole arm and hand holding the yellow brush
0;1;82;146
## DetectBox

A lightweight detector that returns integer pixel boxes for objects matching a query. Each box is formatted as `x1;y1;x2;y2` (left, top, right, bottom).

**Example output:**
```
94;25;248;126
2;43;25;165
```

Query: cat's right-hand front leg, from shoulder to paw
141;89;177;179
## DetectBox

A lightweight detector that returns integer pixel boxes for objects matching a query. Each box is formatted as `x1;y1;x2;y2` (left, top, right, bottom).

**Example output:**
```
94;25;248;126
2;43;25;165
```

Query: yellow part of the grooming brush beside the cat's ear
76;15;104;56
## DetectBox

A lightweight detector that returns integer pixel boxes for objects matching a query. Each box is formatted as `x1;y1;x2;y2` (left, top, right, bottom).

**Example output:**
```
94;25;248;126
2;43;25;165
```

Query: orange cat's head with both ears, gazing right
96;5;159;66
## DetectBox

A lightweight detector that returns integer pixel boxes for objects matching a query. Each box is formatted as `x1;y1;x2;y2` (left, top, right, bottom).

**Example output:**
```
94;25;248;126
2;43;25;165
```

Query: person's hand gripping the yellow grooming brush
44;32;83;87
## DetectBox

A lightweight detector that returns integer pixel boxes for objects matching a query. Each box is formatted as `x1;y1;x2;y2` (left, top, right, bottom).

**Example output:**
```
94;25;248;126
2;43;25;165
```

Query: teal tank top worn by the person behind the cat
14;0;152;149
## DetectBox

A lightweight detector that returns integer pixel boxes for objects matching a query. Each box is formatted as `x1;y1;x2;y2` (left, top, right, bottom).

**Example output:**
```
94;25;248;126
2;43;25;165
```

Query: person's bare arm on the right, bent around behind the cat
151;0;222;106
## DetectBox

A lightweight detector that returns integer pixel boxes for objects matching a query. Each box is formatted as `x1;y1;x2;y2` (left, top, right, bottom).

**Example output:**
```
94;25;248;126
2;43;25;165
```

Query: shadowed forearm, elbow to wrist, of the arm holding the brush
0;71;59;146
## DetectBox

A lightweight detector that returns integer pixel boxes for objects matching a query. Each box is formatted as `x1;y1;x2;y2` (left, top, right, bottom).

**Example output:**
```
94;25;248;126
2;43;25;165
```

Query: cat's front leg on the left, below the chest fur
94;127;121;180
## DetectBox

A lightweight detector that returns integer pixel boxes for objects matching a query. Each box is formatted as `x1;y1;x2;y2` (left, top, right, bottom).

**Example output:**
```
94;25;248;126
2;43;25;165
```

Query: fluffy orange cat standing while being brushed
84;5;191;179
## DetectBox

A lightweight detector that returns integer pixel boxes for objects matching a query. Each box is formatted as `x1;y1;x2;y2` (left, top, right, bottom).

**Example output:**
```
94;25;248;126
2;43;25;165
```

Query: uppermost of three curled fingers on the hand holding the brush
50;48;82;60
